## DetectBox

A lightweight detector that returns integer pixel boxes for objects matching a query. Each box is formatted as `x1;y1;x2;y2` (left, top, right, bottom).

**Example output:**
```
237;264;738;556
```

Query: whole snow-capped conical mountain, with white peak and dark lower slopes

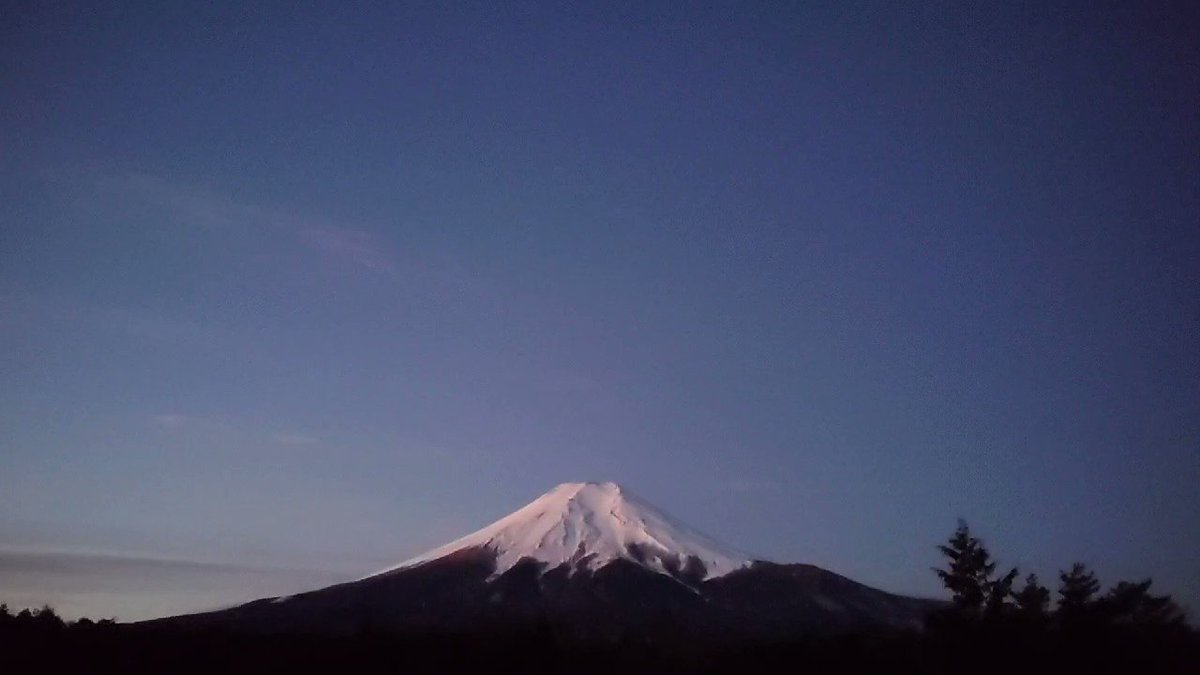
152;483;940;637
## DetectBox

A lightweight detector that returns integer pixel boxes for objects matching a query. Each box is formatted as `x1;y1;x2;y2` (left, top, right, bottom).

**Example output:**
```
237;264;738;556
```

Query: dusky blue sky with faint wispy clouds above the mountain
0;1;1200;620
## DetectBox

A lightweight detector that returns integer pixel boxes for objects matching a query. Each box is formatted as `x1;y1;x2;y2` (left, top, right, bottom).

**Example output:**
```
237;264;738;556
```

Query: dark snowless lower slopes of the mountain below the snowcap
148;549;940;640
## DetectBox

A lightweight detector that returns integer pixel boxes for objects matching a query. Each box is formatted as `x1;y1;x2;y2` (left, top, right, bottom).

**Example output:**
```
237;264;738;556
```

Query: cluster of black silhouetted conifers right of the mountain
922;521;1200;673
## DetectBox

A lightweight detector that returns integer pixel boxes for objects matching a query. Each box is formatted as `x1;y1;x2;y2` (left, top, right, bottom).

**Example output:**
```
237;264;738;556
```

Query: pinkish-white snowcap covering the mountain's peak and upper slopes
372;483;751;579
